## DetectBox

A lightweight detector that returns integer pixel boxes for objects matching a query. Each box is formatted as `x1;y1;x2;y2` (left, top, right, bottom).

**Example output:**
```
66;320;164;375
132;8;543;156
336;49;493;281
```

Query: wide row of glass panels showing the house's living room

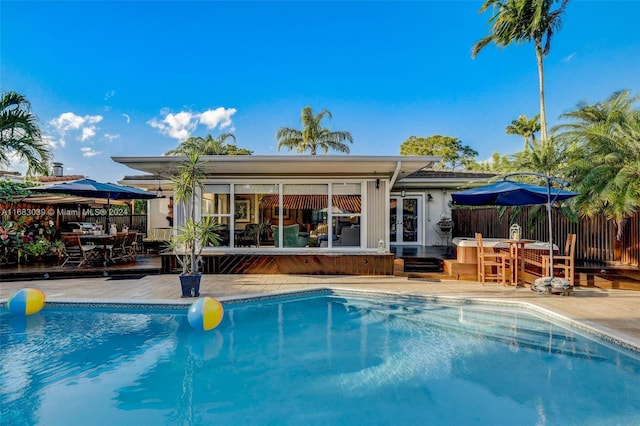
202;183;362;248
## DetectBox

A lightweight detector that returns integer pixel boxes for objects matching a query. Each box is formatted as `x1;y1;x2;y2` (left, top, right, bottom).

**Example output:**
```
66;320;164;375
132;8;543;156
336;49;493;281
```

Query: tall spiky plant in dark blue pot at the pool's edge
169;152;222;297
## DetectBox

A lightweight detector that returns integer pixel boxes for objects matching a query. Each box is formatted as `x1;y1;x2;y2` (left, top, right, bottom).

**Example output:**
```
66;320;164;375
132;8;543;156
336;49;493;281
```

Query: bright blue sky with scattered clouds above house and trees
0;0;640;181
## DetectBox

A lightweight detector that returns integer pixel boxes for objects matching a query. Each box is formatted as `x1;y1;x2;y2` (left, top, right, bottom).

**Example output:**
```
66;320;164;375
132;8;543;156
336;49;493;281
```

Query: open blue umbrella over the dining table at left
29;179;156;229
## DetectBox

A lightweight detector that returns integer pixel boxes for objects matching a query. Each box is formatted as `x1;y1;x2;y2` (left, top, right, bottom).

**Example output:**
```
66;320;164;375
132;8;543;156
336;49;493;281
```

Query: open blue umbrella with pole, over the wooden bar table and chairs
451;172;579;290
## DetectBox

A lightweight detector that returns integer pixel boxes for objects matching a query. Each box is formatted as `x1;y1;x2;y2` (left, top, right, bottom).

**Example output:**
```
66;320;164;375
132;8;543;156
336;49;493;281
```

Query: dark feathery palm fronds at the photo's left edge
0;92;51;175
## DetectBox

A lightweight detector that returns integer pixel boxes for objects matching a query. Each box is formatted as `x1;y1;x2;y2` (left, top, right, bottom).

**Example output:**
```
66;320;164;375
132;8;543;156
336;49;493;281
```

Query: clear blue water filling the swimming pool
0;293;640;426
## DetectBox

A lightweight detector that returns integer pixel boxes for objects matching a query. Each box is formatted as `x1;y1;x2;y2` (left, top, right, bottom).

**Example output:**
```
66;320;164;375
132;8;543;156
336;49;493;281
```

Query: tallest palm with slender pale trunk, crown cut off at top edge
471;0;569;141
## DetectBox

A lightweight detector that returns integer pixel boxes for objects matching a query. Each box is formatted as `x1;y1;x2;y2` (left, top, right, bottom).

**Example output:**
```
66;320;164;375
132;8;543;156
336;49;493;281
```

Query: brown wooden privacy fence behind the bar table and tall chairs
451;206;640;267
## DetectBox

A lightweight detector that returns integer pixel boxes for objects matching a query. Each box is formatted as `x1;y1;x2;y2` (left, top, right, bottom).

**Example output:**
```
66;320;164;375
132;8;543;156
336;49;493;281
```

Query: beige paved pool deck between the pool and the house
0;274;640;348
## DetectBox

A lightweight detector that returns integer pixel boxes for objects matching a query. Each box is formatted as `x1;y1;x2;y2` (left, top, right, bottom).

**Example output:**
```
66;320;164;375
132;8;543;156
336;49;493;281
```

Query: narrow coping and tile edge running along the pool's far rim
0;287;640;354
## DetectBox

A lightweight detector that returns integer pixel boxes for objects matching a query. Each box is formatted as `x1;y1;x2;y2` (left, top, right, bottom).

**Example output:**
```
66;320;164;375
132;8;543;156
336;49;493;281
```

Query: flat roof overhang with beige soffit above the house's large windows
111;155;440;183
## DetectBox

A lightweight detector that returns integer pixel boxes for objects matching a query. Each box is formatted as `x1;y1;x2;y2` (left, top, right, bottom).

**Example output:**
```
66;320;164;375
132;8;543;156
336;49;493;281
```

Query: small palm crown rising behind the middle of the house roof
276;106;353;155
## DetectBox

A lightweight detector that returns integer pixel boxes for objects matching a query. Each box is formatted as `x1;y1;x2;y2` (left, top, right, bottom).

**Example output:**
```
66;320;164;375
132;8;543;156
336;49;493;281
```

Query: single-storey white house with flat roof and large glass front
112;155;496;273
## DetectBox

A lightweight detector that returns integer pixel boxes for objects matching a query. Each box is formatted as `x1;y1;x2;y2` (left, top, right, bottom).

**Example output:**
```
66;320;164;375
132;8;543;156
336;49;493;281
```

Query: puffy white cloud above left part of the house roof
147;107;236;141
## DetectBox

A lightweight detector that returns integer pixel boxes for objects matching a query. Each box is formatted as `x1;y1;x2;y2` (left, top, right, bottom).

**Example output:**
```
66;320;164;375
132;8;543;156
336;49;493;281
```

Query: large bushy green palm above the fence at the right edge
557;91;640;239
